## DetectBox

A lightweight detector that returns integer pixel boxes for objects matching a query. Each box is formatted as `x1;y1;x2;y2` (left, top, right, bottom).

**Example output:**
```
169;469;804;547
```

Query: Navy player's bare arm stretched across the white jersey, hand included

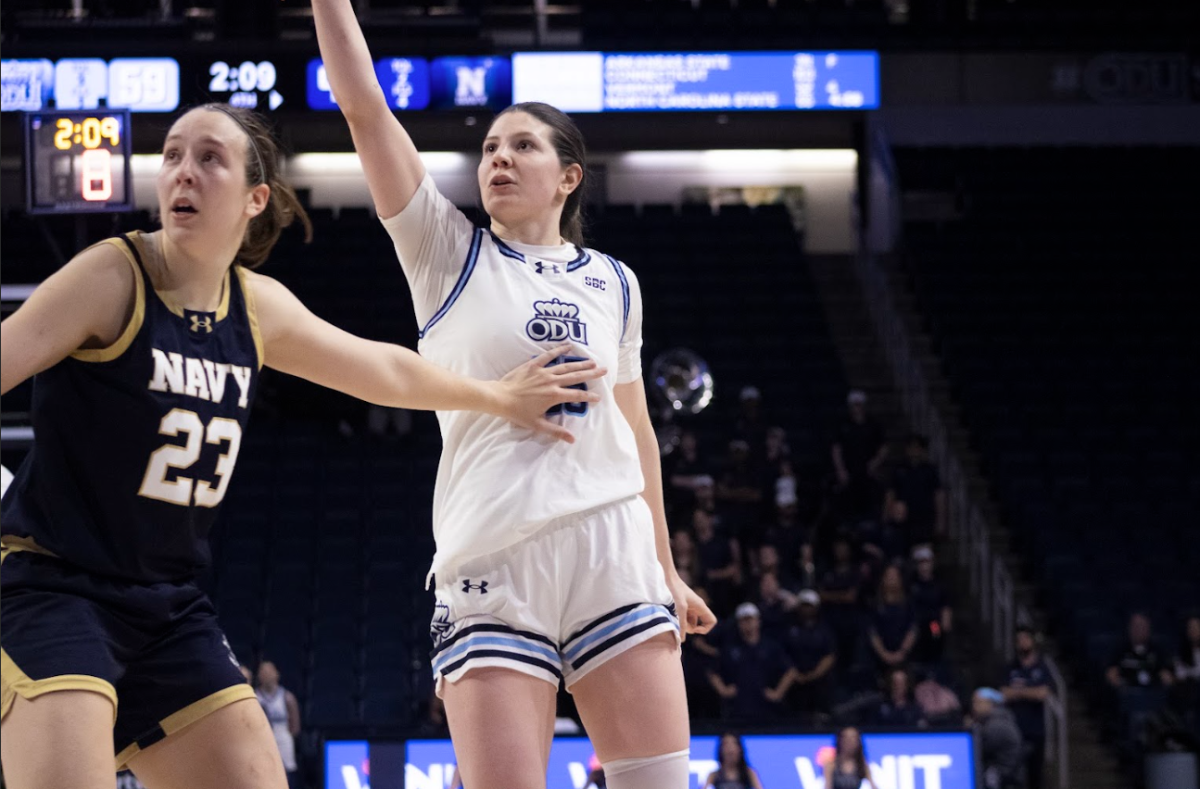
246;268;607;441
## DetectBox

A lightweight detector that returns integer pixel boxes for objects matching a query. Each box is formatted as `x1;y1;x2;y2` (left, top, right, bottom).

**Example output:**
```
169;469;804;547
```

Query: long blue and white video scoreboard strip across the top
0;46;880;113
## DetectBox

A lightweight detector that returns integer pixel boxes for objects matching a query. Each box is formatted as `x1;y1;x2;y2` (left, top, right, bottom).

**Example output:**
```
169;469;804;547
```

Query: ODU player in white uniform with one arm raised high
313;0;714;789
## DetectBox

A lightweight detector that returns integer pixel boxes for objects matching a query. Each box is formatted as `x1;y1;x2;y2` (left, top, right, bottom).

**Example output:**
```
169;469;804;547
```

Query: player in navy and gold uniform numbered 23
0;104;604;789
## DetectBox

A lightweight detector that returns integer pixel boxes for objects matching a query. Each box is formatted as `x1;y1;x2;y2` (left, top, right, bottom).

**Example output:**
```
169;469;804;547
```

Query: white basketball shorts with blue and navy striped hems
430;496;679;695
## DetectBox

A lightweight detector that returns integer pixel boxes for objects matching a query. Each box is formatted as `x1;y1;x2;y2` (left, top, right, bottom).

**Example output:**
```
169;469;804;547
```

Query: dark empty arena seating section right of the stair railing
896;149;1200;772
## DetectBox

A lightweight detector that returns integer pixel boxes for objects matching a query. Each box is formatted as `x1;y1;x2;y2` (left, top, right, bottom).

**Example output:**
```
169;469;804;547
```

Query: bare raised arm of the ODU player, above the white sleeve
312;0;425;218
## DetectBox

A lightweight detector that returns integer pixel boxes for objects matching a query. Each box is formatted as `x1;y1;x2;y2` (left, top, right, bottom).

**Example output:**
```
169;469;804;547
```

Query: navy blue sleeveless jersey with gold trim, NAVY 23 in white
0;234;263;583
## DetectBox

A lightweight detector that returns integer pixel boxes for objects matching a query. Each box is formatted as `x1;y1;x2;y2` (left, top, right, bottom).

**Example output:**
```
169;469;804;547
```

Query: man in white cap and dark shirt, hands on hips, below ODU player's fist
689;603;794;723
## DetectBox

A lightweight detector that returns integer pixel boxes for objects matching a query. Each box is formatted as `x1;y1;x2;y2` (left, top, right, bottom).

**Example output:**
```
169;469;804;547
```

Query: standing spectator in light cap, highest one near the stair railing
832;390;888;520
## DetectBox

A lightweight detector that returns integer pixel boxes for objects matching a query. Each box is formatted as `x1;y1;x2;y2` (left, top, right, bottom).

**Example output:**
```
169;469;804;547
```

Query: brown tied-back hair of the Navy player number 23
199;102;312;269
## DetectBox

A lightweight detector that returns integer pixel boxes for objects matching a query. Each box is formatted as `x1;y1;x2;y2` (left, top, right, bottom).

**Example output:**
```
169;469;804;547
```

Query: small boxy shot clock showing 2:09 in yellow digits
25;110;133;213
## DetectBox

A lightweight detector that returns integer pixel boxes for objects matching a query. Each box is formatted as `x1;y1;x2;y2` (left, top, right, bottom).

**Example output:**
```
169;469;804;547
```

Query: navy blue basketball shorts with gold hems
0;550;254;770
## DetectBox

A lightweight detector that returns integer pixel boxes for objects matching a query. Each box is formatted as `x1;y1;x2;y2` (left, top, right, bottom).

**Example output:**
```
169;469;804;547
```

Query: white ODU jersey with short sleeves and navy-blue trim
383;175;644;573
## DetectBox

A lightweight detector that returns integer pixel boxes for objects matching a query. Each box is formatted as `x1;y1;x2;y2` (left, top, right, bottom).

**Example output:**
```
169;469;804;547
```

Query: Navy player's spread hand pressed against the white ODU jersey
499;345;608;444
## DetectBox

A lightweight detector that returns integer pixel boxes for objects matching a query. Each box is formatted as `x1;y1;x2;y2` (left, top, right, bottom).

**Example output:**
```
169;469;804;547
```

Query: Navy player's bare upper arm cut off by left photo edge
0;245;137;393
